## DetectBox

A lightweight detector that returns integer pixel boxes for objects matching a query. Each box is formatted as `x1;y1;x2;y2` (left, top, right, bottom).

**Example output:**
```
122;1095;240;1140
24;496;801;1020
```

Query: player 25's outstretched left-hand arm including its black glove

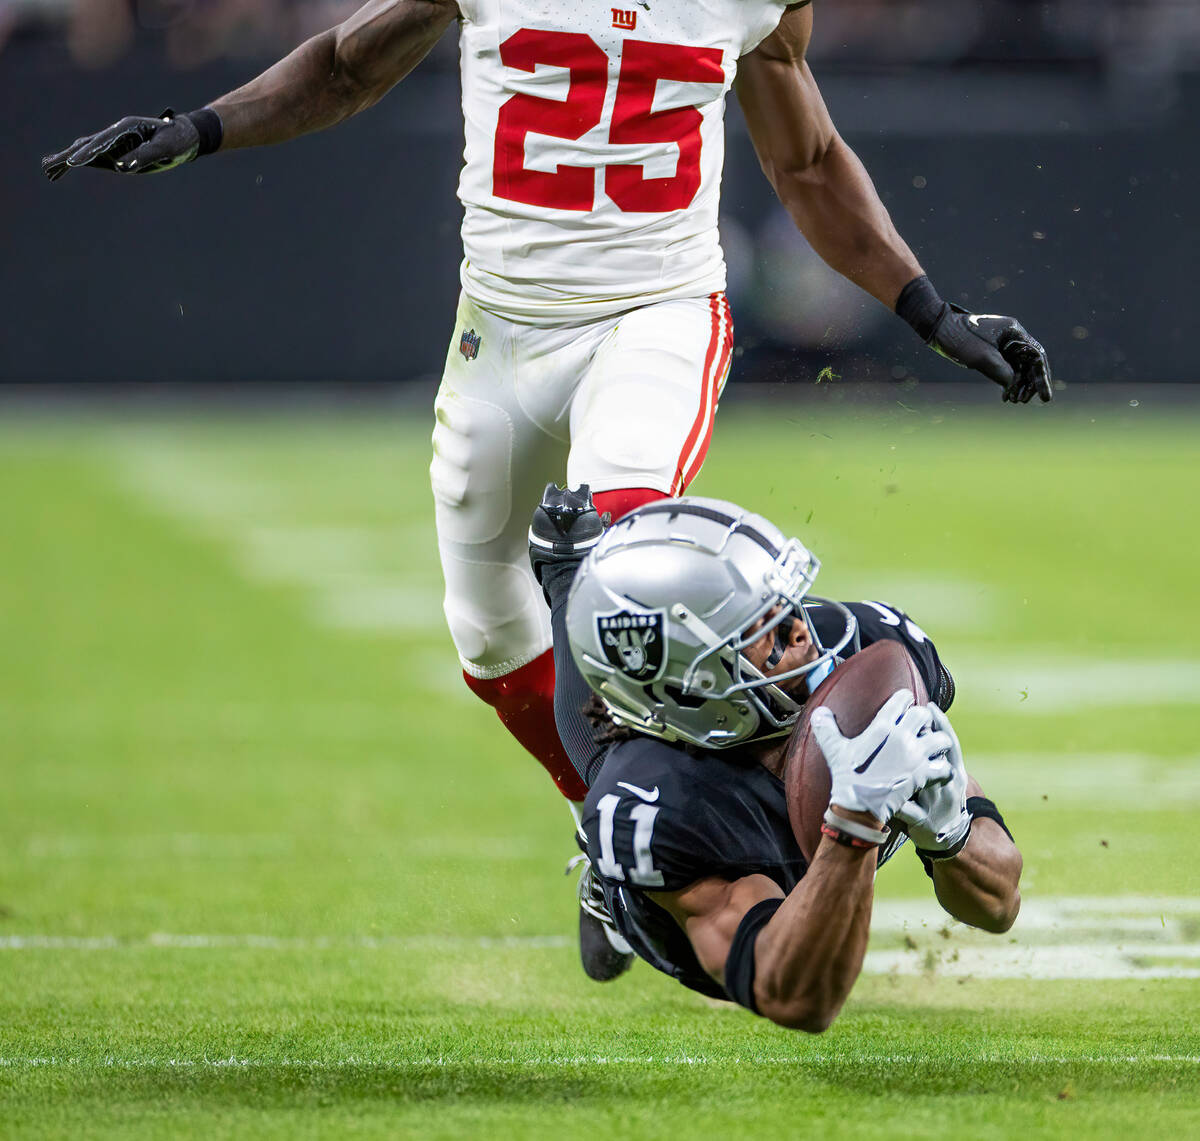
42;0;458;181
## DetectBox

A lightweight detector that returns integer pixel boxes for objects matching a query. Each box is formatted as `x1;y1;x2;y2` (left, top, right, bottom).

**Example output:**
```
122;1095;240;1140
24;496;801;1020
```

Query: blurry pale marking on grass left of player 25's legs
114;439;444;633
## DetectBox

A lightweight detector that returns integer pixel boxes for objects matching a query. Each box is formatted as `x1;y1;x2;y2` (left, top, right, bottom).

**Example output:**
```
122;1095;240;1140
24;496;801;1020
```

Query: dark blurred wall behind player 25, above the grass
0;28;1200;382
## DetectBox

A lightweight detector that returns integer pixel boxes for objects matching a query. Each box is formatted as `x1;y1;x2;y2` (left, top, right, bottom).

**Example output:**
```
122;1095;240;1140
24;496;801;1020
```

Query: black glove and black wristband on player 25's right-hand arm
896;277;1054;404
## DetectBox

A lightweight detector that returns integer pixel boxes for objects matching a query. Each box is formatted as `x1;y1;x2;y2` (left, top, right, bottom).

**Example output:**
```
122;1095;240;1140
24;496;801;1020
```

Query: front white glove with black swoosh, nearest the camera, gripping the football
809;690;954;824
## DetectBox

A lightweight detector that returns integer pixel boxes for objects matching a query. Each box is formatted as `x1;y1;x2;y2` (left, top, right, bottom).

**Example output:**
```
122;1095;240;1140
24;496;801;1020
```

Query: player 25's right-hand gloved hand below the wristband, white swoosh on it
929;302;1054;404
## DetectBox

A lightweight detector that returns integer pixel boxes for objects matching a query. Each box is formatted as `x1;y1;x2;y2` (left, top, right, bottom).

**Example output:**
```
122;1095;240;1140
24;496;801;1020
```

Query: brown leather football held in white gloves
784;642;929;861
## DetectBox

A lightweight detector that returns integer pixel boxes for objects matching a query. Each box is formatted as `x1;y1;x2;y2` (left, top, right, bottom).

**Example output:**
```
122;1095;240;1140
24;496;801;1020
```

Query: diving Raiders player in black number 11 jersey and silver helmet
529;485;1021;1032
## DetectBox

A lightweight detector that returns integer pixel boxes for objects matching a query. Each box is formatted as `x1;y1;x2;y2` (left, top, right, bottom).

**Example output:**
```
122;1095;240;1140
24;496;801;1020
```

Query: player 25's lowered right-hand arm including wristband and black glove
736;6;1054;403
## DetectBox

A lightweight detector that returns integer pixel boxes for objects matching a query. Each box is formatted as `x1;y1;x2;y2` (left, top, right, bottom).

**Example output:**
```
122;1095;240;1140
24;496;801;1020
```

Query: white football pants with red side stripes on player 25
430;293;733;678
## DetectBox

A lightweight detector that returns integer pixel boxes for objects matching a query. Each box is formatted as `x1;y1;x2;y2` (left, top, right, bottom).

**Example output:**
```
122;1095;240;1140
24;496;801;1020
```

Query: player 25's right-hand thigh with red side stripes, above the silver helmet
568;294;733;503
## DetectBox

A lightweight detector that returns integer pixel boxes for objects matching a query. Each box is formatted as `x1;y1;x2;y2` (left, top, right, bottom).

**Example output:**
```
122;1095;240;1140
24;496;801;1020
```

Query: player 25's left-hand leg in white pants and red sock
430;292;600;800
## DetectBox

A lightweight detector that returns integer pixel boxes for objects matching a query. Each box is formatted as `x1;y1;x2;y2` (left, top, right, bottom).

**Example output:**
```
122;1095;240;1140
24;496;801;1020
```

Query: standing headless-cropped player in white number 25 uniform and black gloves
42;0;1052;983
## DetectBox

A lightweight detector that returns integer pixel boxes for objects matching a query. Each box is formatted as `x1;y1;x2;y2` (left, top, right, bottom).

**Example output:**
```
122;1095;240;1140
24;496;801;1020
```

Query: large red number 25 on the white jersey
492;28;725;214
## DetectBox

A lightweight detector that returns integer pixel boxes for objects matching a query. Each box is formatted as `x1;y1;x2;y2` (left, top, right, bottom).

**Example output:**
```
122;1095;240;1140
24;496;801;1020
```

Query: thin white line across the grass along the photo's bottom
0;1051;1200;1070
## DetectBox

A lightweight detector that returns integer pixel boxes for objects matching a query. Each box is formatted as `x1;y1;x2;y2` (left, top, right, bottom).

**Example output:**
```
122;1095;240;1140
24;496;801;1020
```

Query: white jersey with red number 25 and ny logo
458;0;788;324
